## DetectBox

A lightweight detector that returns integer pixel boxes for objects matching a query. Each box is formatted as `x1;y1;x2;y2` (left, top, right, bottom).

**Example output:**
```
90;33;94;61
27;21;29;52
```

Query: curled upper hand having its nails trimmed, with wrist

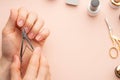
0;7;50;80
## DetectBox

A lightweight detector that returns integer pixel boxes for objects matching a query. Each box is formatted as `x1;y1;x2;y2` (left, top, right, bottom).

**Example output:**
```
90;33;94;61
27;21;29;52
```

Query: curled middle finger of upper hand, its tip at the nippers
24;12;37;33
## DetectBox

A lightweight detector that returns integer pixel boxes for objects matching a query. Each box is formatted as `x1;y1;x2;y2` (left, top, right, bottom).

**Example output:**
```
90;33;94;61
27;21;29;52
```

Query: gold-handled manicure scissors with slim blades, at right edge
105;18;120;59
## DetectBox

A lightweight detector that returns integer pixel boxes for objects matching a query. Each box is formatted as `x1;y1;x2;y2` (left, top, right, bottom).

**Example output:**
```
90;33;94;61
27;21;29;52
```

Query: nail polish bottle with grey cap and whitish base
88;0;100;16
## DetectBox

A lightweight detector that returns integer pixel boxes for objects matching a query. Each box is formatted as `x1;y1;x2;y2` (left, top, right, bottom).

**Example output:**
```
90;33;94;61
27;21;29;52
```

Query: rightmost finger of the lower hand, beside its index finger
37;55;49;80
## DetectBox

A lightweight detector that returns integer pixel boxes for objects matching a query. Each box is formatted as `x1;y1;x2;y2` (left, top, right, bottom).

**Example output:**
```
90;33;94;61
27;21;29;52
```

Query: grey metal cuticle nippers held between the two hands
20;29;34;63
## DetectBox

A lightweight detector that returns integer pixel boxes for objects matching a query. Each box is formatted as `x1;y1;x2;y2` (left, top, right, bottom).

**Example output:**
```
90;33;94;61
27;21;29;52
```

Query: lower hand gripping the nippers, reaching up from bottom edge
10;47;50;80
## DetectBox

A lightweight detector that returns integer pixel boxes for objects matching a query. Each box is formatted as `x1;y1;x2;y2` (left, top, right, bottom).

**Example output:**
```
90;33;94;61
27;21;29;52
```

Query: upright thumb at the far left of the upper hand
2;9;18;35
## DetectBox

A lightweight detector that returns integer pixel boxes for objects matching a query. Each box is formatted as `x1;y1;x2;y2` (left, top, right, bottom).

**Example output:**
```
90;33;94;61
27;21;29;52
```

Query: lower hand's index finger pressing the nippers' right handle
23;47;41;80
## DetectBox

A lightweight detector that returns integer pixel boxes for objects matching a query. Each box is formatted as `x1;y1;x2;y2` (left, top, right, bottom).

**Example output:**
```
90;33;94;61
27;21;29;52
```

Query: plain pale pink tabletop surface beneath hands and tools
0;0;120;80
